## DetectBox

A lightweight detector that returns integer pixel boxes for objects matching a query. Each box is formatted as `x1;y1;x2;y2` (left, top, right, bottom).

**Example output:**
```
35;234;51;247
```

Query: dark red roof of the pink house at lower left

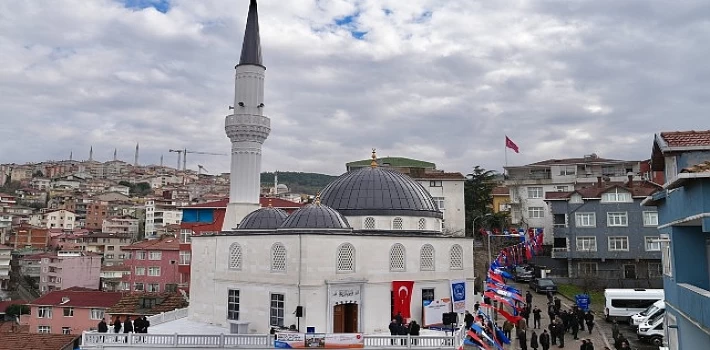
30;287;122;308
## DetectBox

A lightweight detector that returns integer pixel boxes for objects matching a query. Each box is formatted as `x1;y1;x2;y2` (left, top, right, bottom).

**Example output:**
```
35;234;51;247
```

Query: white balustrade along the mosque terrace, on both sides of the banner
81;332;459;349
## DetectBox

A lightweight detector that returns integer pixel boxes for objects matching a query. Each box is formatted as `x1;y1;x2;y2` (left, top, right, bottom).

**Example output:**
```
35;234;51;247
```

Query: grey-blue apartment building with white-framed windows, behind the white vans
545;175;662;288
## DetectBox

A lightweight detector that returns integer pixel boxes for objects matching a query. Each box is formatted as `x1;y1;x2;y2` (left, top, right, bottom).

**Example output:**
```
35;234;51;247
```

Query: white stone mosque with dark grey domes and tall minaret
188;0;474;334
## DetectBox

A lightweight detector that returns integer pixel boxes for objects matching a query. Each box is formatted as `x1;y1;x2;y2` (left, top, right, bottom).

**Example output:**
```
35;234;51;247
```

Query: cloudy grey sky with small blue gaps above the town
0;0;710;174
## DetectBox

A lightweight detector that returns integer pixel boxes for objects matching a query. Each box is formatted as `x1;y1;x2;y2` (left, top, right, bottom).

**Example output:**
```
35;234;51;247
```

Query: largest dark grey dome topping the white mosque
320;166;443;219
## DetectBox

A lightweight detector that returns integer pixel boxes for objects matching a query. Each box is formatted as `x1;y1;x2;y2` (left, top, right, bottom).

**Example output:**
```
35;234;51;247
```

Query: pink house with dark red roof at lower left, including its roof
21;287;122;334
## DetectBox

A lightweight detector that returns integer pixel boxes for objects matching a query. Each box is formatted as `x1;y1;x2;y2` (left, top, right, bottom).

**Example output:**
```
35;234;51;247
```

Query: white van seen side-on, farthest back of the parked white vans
604;288;664;323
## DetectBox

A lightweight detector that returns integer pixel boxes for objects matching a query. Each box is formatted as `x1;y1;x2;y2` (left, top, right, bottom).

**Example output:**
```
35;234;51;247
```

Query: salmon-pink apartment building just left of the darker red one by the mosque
121;236;180;293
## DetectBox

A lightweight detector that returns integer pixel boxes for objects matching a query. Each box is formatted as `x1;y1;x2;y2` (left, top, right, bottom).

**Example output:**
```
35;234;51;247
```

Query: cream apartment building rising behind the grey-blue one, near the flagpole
504;154;652;245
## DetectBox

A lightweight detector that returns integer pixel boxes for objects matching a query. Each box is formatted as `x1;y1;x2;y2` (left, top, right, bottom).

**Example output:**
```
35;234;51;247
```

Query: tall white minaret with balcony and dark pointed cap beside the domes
222;0;271;231
